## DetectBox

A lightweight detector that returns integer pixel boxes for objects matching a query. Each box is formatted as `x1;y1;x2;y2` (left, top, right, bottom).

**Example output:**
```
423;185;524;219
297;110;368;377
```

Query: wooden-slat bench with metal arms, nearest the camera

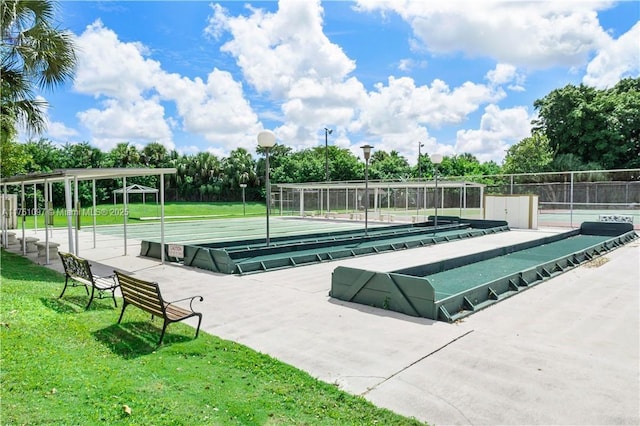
116;271;204;345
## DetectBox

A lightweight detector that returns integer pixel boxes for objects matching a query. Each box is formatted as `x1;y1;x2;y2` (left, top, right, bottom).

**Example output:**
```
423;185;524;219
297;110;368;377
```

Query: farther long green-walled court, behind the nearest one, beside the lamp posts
140;217;509;274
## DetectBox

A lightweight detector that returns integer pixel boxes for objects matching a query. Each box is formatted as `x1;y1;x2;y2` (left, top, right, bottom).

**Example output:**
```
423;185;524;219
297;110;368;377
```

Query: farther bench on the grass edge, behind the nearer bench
58;251;118;309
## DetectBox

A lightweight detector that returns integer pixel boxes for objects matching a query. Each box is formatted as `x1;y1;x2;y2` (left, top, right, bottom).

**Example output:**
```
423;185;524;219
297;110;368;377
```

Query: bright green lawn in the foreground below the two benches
0;250;428;425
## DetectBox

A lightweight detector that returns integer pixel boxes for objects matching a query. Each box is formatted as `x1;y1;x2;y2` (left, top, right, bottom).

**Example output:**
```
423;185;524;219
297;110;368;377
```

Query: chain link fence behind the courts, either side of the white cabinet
271;169;640;229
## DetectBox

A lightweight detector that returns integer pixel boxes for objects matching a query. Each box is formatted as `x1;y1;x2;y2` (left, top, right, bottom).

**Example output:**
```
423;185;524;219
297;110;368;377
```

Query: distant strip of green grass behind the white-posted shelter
18;202;266;229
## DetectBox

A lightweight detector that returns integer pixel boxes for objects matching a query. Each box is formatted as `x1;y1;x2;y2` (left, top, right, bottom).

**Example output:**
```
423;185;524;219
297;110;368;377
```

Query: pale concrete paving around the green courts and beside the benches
2;225;640;425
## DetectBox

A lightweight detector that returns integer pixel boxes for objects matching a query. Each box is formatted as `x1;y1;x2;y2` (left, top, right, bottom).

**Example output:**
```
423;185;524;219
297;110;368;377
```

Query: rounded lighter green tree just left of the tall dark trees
502;132;553;174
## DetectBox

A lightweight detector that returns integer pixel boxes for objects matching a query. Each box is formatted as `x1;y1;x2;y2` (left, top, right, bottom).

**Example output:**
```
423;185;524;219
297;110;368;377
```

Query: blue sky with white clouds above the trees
33;0;640;164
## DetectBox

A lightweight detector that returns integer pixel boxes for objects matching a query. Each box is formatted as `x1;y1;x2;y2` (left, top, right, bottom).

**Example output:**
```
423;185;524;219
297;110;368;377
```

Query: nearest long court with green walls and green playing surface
331;222;638;322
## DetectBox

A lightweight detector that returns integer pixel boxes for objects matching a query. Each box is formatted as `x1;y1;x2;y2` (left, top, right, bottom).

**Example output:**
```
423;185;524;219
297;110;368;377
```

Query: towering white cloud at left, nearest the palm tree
74;21;260;152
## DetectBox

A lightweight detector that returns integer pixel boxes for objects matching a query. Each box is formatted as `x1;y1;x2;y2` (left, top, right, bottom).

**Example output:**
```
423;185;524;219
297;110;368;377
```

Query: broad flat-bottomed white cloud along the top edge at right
357;0;612;68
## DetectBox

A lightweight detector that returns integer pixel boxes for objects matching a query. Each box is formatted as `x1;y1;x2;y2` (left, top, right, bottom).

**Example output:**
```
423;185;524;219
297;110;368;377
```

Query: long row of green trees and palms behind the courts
6;139;500;205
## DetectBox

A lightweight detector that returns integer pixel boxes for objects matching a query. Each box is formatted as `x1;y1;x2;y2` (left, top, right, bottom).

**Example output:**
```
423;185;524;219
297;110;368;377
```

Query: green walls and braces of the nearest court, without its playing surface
330;222;638;322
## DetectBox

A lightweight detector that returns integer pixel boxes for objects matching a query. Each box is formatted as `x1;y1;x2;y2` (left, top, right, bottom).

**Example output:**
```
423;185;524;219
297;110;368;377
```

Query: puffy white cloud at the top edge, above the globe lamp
206;0;355;97
